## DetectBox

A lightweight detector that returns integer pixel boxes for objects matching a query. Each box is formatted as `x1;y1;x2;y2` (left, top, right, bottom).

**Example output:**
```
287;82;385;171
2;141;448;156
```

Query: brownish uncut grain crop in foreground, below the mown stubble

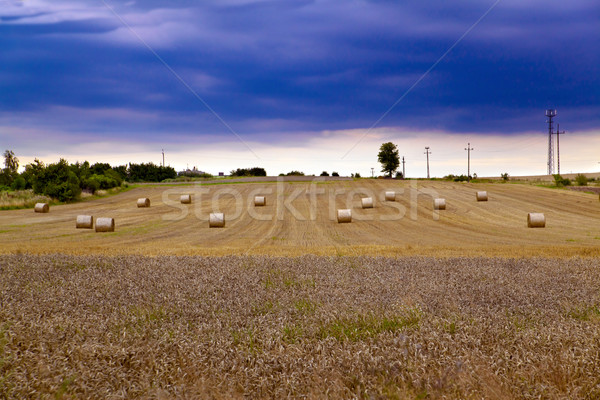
0;255;600;399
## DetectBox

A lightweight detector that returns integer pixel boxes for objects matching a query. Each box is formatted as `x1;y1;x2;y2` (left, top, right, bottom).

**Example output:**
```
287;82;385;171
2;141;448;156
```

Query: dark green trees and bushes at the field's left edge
0;150;177;202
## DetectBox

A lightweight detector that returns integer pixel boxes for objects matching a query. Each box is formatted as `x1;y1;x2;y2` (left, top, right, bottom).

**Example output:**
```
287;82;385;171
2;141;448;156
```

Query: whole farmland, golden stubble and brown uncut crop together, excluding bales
0;180;600;399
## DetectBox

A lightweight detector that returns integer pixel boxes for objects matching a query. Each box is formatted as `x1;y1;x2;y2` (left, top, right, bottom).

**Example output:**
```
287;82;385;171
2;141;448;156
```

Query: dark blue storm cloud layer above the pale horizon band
0;0;600;145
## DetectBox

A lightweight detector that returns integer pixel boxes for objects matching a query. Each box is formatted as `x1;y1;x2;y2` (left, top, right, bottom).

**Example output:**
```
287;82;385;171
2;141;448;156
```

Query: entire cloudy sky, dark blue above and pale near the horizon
0;0;600;177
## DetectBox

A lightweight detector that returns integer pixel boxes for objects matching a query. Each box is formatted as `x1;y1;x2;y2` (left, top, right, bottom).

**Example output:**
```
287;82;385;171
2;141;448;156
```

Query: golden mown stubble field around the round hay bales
0;179;600;257
